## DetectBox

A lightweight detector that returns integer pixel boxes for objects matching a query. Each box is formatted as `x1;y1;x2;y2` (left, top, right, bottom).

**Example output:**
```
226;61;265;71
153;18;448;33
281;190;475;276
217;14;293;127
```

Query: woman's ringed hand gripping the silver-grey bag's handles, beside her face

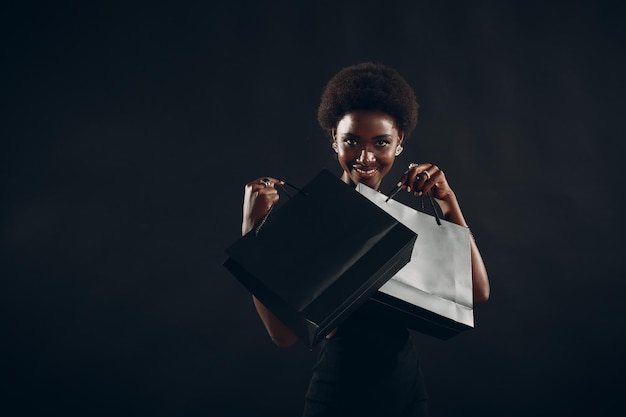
397;162;454;201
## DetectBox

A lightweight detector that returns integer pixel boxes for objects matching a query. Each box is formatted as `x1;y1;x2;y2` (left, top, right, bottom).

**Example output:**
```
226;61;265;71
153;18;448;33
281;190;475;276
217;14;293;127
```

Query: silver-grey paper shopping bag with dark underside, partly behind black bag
356;184;474;340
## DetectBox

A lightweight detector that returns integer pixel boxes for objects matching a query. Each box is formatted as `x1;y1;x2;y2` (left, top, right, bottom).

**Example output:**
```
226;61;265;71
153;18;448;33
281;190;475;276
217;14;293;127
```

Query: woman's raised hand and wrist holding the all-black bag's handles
241;177;285;235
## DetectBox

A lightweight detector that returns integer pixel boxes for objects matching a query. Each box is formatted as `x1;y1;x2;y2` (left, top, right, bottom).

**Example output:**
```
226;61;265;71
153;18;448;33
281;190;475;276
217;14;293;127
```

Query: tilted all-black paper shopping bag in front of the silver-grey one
224;170;416;348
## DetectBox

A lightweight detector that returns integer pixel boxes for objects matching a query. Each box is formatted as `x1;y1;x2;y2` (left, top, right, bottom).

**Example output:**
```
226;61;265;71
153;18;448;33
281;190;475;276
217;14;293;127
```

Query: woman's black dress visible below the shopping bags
304;312;428;417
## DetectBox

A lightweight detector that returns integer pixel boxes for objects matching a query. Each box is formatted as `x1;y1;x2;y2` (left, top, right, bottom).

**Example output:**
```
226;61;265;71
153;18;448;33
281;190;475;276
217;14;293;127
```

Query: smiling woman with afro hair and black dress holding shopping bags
242;63;489;417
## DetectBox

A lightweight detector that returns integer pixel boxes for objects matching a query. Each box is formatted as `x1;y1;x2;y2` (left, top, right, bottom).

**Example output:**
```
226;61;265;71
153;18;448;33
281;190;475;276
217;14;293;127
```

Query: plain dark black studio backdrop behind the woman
0;1;626;416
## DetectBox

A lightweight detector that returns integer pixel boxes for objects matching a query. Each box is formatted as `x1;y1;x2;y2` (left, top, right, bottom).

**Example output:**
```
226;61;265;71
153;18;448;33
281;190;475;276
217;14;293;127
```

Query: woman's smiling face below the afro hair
333;110;404;190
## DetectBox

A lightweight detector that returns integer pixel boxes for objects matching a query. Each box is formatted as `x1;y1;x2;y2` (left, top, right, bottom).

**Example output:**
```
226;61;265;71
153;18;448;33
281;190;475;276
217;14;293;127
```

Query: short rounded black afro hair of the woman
317;62;418;137
